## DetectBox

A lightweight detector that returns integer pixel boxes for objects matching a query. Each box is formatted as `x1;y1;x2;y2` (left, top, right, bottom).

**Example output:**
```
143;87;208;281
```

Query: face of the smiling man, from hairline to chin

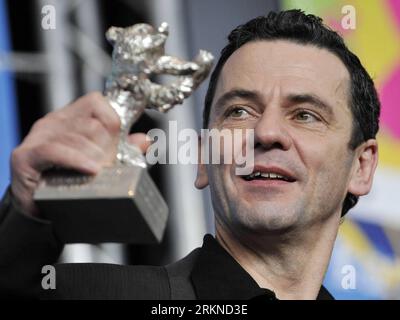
196;40;355;233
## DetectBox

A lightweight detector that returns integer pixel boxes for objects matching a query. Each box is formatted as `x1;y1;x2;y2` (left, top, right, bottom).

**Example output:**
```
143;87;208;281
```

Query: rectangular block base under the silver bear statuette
34;165;168;244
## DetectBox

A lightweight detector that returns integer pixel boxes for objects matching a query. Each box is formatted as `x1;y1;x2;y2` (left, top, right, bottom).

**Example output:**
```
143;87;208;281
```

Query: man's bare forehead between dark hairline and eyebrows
216;40;350;103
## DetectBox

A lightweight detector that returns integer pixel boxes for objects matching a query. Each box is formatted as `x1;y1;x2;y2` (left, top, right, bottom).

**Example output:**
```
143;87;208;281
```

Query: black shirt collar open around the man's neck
191;235;333;300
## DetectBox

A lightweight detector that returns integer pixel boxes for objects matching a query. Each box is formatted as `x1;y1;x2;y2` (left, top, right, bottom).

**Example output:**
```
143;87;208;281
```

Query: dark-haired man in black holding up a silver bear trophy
0;10;380;299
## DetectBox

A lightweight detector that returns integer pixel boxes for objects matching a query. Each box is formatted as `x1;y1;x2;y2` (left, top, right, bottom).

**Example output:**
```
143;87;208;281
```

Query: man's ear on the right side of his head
348;139;378;196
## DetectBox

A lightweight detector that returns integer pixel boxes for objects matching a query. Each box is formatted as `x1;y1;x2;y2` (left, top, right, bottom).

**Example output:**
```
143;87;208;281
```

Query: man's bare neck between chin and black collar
216;217;339;299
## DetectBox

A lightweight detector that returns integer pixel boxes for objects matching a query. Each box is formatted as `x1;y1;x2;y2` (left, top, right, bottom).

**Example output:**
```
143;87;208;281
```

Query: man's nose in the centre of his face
254;106;292;150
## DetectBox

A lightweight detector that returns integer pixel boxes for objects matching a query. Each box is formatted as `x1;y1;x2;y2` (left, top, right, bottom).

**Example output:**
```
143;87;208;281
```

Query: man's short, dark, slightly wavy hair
203;9;380;216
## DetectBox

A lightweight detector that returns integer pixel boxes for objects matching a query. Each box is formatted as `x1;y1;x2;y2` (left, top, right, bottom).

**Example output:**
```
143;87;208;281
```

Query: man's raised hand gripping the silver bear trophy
11;92;121;218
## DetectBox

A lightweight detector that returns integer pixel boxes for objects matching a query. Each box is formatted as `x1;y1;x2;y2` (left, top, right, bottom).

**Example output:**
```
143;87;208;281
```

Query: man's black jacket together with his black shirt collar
0;192;332;300
